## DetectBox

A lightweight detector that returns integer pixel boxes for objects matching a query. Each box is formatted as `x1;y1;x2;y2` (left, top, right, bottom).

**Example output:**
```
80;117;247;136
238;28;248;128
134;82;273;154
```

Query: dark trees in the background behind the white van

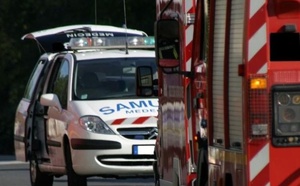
0;0;155;154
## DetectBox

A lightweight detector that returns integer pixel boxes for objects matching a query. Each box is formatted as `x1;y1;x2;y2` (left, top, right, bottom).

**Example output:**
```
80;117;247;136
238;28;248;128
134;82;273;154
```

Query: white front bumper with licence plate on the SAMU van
71;136;155;177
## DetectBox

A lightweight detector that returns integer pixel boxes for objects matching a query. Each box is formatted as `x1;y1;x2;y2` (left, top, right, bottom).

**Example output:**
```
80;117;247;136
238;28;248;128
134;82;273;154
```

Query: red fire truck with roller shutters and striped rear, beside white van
137;0;300;186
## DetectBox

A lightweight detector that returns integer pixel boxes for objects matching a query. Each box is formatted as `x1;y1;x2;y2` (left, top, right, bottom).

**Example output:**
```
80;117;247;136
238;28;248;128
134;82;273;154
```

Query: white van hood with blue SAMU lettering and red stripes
71;99;158;125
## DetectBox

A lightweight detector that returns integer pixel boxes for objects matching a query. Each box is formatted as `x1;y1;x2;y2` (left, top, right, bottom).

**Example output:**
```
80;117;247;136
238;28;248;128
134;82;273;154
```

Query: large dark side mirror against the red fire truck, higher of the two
155;19;180;68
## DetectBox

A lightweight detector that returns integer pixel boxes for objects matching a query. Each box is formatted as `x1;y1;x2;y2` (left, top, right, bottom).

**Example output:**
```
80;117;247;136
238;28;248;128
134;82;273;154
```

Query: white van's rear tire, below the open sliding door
29;156;53;186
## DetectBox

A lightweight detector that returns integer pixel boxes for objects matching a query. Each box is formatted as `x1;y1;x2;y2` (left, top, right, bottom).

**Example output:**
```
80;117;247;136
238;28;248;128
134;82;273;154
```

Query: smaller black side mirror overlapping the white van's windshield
136;66;154;96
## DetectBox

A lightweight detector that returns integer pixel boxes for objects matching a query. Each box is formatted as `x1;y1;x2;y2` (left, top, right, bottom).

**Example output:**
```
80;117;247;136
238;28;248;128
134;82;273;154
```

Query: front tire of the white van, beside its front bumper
65;143;87;186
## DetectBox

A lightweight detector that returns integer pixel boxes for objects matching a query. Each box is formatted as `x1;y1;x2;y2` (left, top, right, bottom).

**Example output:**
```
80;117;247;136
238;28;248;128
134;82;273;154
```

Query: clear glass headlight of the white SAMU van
79;116;115;134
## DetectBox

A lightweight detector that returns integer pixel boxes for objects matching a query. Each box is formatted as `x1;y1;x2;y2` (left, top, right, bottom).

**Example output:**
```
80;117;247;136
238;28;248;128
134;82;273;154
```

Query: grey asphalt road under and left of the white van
0;155;154;186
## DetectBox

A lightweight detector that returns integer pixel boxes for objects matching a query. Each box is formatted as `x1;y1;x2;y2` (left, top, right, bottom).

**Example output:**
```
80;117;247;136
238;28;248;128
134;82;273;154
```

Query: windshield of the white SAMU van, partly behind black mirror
73;58;157;100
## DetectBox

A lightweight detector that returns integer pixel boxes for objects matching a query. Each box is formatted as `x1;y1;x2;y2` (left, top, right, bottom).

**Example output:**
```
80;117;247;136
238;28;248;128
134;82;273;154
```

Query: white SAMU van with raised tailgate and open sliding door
14;25;158;186
